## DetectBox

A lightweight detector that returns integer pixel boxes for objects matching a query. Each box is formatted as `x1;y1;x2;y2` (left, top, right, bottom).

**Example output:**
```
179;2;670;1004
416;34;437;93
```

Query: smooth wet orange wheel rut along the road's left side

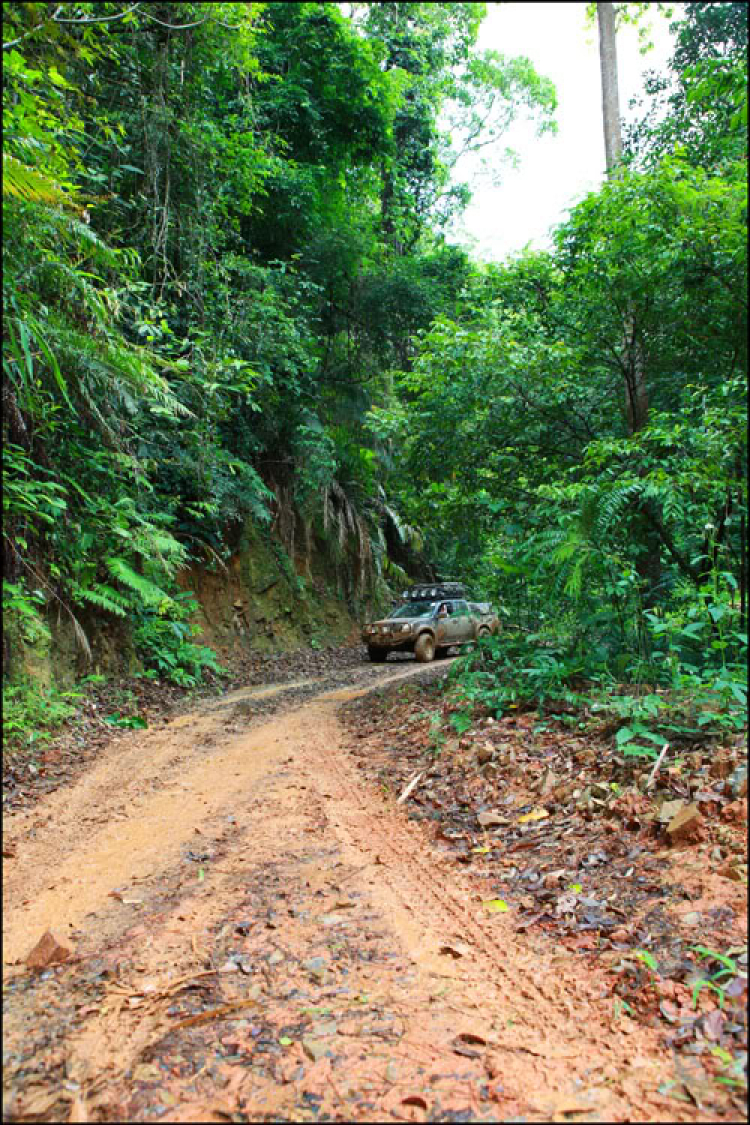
3;665;445;966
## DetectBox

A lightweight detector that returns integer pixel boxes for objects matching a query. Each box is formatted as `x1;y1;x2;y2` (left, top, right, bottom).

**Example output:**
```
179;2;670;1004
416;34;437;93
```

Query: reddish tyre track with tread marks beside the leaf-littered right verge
294;704;668;1119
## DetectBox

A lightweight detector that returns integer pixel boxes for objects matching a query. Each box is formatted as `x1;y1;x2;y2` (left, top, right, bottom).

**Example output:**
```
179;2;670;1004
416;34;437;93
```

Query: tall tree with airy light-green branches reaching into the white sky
353;2;557;254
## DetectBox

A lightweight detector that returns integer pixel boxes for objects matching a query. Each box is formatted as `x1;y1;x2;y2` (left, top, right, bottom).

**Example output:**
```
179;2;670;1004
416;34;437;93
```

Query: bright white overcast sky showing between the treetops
453;2;681;261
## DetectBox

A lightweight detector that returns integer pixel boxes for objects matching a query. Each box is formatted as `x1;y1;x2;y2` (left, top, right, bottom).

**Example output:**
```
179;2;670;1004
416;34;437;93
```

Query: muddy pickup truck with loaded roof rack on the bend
362;583;497;664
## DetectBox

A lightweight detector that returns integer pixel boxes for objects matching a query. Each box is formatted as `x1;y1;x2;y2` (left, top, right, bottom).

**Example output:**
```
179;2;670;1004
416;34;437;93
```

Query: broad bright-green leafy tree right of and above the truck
372;163;747;630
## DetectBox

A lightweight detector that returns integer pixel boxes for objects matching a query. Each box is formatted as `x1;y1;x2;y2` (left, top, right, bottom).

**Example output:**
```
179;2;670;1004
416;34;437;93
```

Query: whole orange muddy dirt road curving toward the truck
3;663;723;1122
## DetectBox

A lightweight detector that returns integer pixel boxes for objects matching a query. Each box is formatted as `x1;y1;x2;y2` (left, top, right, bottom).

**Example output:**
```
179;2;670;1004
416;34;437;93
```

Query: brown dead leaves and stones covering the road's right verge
346;666;747;1109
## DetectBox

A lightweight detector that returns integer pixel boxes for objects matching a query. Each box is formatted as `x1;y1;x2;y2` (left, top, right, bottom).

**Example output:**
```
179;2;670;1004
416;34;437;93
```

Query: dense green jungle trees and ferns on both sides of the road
2;2;748;783
